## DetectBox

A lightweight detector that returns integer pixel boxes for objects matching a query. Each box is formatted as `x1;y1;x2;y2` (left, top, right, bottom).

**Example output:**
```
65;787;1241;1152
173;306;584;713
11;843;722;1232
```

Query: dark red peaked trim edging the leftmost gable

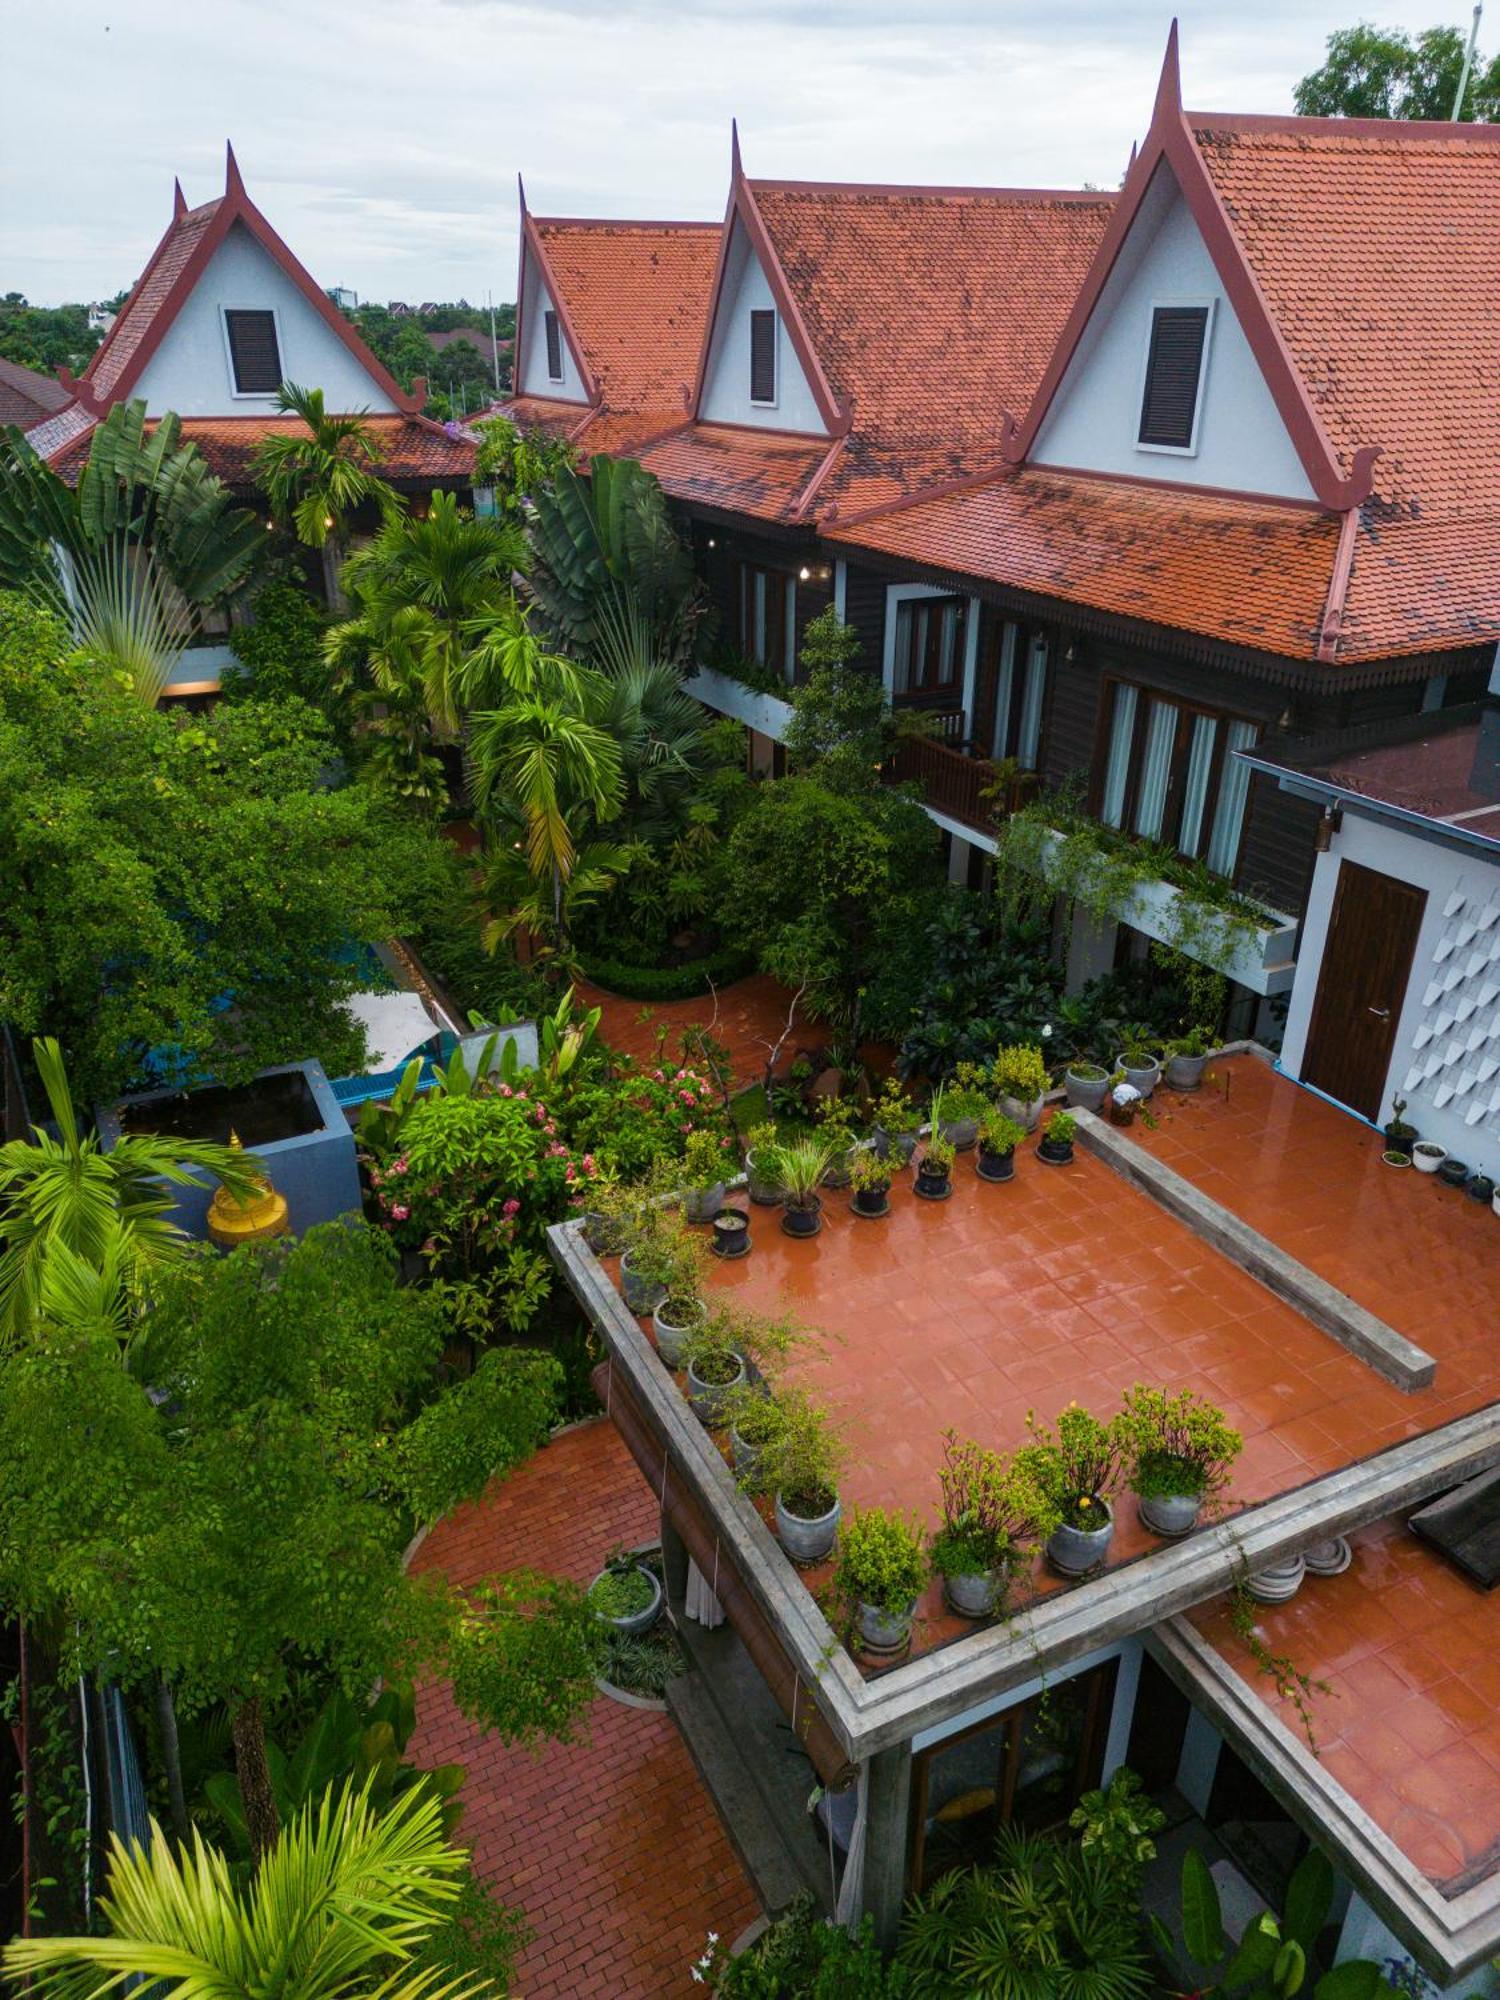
60;146;426;416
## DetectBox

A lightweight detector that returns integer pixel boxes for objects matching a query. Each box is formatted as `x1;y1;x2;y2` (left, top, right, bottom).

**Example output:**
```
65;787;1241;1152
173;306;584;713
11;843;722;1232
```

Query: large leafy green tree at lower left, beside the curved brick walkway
0;1224;580;1856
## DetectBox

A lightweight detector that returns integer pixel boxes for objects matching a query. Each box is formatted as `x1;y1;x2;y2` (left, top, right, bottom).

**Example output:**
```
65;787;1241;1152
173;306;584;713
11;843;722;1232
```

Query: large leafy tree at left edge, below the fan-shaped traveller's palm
0;592;432;1102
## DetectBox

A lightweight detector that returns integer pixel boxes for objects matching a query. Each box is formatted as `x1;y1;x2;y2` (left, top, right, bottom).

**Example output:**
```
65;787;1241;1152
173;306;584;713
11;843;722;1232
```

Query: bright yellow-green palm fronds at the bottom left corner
4;1786;496;2000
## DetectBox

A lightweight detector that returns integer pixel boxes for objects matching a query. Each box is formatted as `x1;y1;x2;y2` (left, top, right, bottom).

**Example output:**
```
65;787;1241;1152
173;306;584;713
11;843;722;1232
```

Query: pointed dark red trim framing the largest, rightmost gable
1004;22;1378;512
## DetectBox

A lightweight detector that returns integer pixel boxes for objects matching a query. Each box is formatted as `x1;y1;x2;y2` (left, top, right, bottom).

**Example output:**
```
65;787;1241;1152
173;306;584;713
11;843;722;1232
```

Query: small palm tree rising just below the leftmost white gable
250;382;400;608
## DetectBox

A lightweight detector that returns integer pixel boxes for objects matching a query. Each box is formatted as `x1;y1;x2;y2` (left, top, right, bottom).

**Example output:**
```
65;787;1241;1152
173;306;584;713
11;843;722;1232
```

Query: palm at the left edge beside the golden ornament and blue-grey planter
0;1036;260;1342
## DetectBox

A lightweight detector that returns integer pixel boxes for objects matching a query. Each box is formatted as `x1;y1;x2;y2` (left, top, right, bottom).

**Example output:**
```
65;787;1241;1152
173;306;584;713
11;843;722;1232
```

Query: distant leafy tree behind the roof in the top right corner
1292;20;1500;122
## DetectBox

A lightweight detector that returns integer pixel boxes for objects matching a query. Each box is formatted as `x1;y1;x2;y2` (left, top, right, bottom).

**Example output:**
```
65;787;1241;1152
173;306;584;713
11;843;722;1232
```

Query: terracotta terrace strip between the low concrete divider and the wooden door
1130;1056;1500;1360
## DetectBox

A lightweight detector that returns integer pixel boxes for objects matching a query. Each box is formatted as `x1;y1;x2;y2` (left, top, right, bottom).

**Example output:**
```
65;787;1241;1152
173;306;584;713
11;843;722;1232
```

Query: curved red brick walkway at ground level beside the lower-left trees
412;1420;760;2000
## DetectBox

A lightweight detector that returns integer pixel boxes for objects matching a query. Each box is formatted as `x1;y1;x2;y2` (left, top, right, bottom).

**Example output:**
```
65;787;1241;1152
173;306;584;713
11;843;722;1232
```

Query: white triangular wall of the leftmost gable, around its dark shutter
134;222;396;416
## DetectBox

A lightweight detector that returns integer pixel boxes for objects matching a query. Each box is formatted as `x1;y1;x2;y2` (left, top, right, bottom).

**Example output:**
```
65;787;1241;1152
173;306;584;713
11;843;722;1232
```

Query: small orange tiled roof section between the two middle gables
532;220;720;416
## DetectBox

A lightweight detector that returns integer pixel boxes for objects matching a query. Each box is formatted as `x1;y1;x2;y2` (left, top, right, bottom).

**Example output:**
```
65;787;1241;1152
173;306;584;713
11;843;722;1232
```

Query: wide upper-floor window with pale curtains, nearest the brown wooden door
1098;680;1260;876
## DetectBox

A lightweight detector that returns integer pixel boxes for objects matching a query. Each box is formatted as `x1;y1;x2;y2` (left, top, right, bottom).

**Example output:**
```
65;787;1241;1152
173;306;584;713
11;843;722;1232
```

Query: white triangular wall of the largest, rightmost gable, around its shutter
1026;160;1316;500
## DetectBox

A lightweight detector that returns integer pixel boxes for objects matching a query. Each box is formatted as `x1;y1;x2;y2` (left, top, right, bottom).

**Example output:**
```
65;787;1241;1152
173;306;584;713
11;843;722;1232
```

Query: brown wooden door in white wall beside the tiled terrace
1302;862;1428;1122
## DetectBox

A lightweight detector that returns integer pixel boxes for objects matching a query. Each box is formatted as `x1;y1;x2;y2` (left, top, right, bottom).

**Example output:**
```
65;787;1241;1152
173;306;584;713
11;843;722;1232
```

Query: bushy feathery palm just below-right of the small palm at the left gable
324;494;526;738
